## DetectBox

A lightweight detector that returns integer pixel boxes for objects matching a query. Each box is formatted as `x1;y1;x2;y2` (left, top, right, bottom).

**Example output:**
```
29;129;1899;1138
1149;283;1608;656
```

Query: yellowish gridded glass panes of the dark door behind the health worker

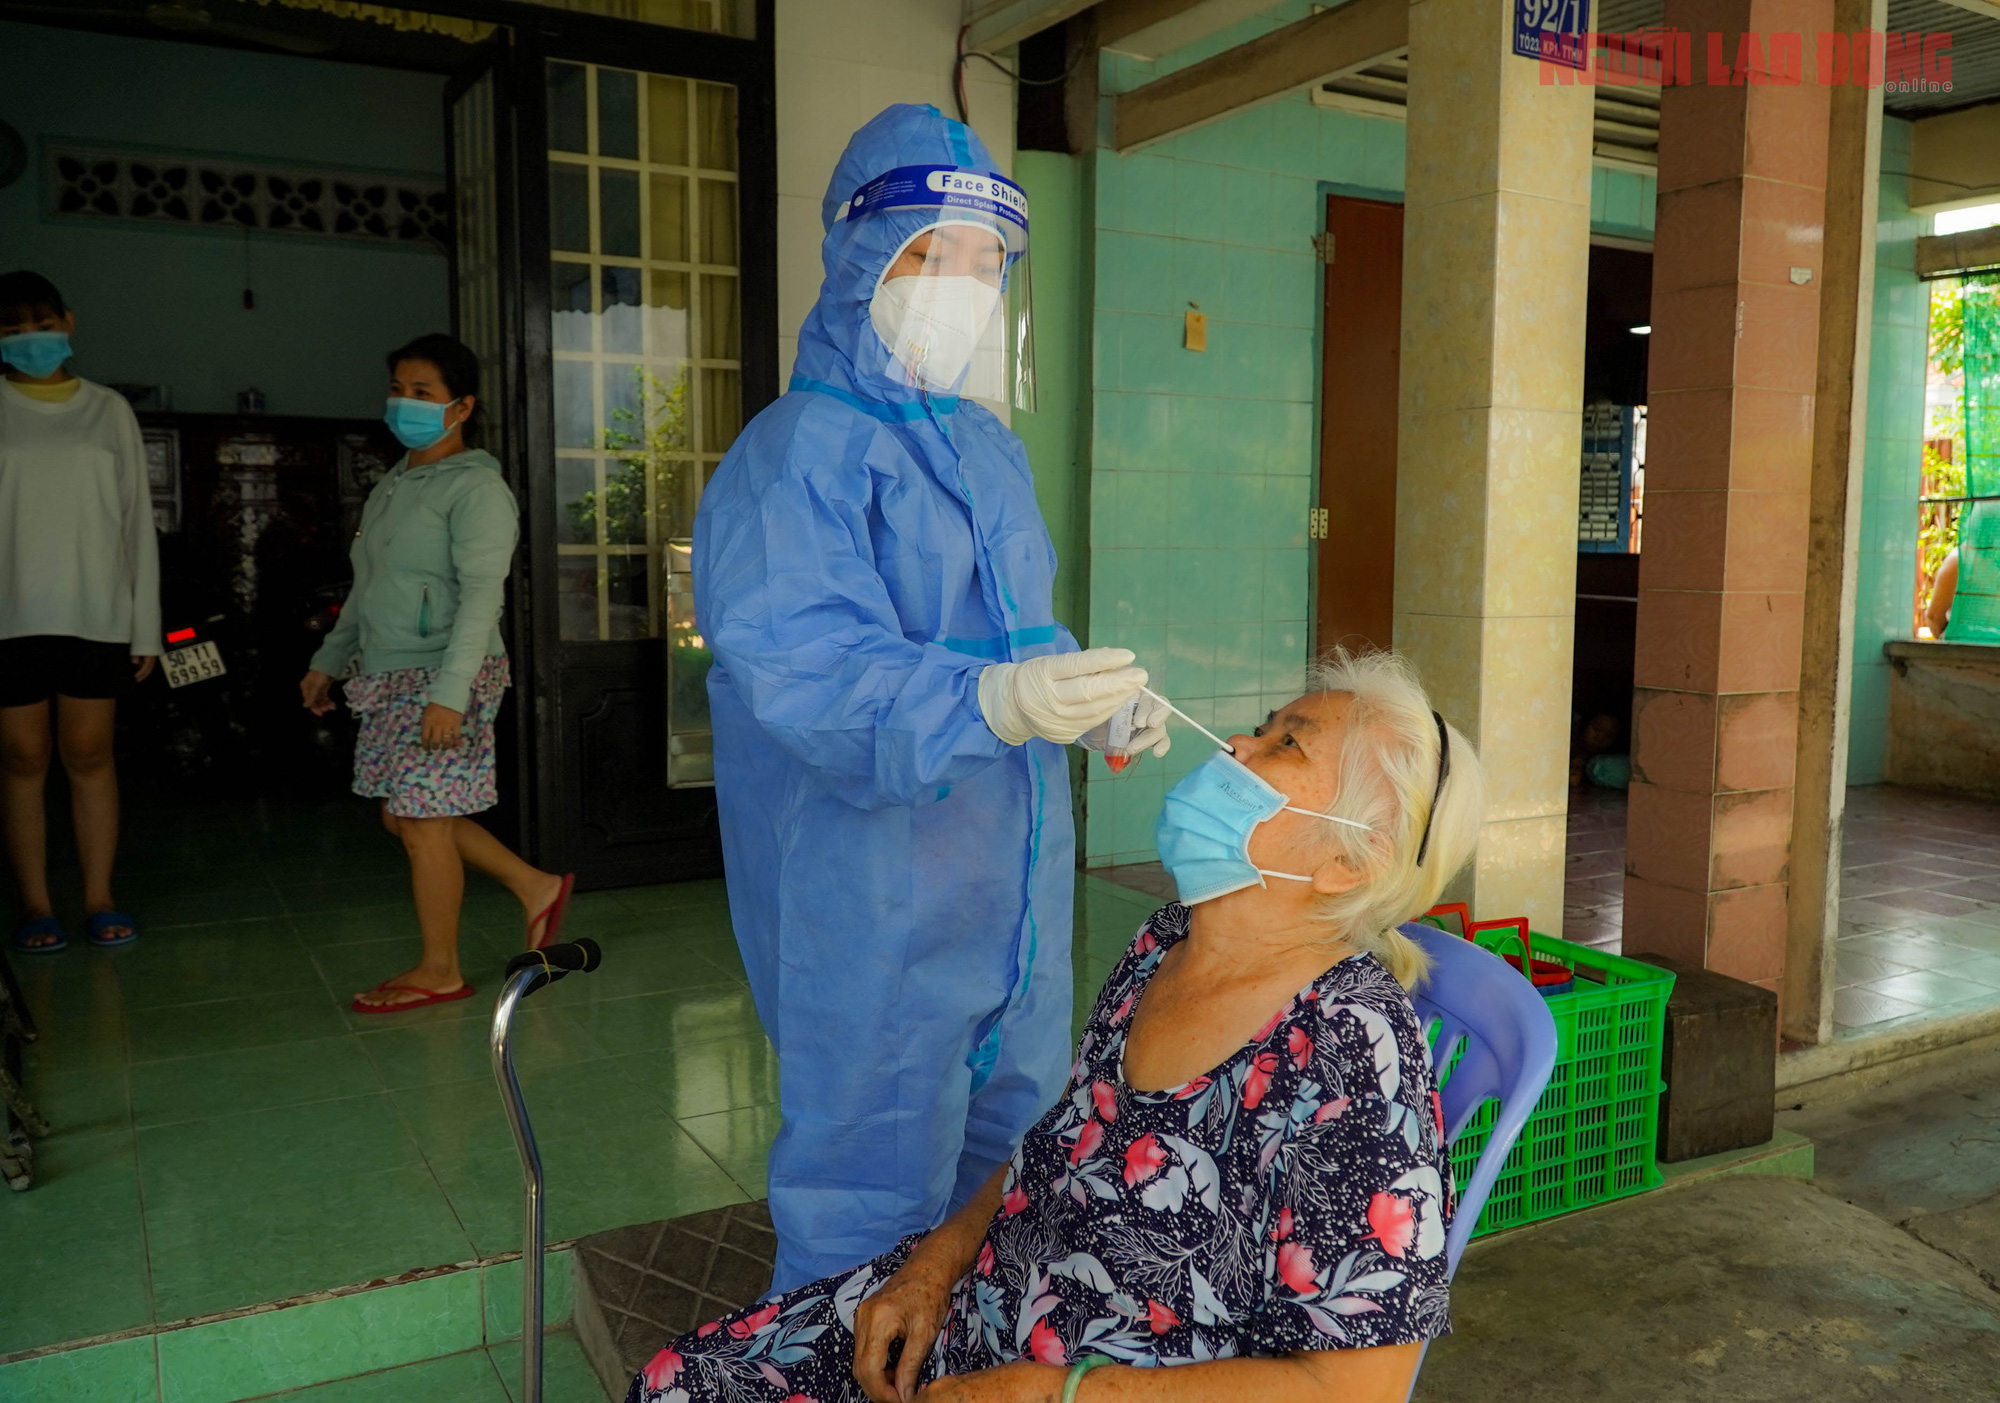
546;60;742;785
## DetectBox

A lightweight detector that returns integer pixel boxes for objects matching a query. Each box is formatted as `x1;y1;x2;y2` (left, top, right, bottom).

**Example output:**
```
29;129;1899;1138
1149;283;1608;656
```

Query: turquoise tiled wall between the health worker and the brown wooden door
1084;0;1654;865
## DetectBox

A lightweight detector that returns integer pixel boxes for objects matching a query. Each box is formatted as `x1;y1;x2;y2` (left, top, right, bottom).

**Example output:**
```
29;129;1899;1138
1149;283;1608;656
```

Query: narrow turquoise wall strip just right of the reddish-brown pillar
1848;118;1930;783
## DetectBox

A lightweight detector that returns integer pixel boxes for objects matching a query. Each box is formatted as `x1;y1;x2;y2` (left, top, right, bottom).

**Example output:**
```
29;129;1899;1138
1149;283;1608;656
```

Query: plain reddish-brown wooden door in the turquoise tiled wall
1314;196;1402;652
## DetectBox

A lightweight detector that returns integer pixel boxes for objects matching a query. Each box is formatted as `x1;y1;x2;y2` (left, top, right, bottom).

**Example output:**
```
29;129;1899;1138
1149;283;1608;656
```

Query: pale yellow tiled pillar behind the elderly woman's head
1396;0;1590;933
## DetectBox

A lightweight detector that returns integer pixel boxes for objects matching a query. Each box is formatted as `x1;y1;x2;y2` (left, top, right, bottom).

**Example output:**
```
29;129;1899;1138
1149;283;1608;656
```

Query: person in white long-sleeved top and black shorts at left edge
0;272;160;953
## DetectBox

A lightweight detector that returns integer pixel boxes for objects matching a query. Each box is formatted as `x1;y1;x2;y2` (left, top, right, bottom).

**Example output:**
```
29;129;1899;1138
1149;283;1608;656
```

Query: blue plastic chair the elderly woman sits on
1402;921;1556;1393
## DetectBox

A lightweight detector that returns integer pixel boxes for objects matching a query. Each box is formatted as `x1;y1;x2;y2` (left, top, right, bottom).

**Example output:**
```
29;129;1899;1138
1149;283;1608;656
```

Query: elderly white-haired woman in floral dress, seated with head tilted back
628;654;1482;1403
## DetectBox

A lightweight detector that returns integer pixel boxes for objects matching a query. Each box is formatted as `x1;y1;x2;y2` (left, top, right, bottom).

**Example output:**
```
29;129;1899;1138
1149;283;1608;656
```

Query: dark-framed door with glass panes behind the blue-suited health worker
450;21;778;889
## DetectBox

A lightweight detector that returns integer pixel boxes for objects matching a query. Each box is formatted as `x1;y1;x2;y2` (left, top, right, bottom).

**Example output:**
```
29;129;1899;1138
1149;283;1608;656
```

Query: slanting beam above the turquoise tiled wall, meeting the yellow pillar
1112;0;1410;152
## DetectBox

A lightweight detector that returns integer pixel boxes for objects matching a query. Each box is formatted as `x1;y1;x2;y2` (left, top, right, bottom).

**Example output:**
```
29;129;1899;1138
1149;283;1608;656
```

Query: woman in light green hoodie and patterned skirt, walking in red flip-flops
298;334;574;1013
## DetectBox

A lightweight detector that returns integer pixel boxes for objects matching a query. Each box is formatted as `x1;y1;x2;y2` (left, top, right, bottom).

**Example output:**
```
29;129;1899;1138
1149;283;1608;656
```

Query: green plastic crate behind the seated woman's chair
1442;931;1674;1237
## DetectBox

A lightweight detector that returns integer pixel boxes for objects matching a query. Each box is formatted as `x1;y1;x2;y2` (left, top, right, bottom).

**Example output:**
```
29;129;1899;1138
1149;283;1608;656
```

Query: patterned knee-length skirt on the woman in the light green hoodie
342;658;512;817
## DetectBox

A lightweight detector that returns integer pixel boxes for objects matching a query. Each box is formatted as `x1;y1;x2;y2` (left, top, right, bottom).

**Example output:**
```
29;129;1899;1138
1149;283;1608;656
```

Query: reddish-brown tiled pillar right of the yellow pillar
1624;0;1832;989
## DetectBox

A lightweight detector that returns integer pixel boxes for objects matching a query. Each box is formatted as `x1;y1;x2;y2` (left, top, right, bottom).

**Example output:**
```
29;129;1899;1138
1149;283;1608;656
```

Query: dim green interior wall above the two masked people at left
0;24;450;418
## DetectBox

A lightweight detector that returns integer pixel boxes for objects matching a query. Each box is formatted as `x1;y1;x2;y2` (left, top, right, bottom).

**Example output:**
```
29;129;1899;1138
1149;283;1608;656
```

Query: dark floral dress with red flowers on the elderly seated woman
628;905;1452;1403
